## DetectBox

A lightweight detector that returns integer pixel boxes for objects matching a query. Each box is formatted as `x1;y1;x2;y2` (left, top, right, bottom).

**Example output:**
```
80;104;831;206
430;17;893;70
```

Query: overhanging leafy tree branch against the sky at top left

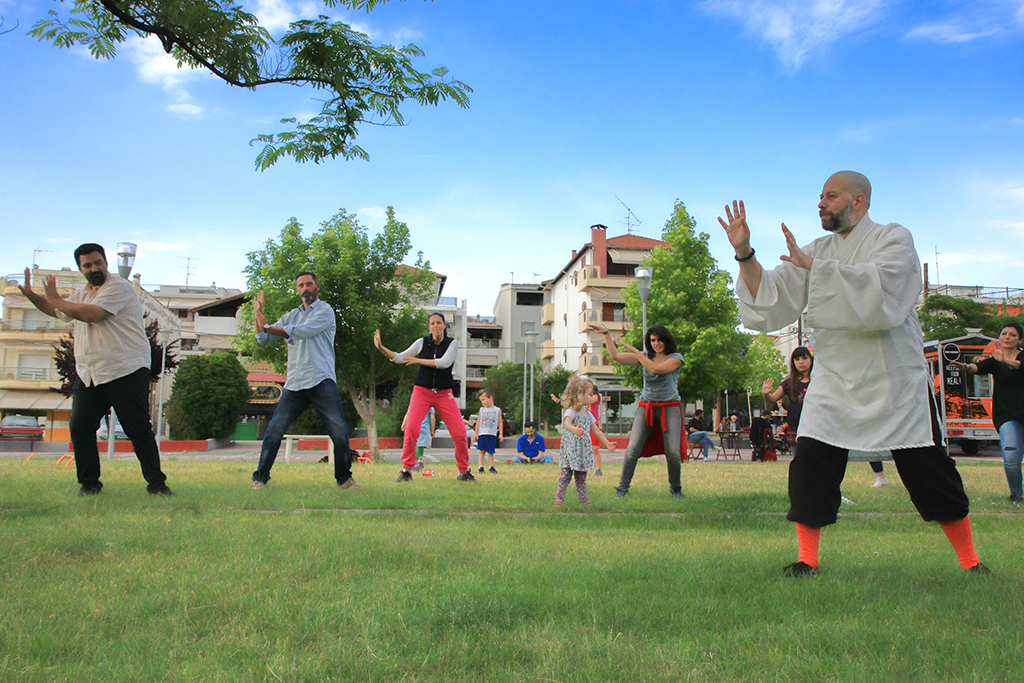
29;0;472;170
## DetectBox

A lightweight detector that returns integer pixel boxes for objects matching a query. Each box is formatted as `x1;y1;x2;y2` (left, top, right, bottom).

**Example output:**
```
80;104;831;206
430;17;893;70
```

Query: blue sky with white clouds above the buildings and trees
0;0;1024;315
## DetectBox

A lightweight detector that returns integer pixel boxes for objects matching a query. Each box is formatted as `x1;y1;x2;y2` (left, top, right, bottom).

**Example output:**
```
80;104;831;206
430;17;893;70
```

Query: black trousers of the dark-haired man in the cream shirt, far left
70;368;167;492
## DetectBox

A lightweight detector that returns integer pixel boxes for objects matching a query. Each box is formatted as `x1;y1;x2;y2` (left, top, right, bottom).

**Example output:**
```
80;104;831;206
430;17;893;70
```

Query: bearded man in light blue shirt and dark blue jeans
253;270;360;489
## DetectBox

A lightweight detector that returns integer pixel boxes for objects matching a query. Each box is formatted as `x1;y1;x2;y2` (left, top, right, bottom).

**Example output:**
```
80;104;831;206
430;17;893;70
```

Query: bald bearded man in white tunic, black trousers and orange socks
719;171;989;577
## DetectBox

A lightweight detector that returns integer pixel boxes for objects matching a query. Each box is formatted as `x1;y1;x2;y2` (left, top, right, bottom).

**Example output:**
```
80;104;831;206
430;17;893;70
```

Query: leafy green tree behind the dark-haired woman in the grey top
615;201;749;404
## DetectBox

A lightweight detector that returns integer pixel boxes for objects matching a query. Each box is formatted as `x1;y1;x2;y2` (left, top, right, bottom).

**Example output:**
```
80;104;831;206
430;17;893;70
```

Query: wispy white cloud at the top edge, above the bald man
705;0;888;71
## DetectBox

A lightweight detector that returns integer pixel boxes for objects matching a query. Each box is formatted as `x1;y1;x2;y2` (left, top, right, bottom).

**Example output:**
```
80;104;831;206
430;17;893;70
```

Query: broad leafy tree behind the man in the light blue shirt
234;207;435;456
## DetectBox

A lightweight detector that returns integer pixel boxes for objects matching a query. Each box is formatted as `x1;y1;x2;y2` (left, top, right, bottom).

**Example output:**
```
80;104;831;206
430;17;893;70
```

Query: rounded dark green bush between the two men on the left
167;351;250;439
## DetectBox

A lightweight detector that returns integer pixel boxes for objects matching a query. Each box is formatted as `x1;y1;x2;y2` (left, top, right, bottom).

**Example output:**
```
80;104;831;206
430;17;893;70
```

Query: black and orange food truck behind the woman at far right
925;334;999;456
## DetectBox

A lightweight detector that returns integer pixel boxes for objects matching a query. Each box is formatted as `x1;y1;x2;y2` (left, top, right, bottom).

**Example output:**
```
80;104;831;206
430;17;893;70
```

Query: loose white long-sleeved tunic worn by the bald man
736;214;933;452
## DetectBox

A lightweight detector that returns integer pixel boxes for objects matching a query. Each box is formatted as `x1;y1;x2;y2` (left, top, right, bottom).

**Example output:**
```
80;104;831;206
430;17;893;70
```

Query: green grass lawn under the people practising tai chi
0;456;1024;683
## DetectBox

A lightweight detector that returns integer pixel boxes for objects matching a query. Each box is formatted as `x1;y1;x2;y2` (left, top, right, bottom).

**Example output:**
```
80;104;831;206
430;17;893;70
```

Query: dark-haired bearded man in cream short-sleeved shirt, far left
18;243;171;496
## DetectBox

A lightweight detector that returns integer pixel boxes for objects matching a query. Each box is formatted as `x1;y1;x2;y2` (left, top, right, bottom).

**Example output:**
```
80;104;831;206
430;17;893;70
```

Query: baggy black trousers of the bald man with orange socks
786;393;970;527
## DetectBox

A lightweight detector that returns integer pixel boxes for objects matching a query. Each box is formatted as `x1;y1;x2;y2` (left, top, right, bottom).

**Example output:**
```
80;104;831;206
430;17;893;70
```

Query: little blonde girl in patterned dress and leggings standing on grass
555;377;615;505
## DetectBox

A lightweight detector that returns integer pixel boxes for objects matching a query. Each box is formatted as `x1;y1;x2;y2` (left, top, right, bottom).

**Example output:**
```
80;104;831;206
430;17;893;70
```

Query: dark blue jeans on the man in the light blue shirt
253;380;352;483
